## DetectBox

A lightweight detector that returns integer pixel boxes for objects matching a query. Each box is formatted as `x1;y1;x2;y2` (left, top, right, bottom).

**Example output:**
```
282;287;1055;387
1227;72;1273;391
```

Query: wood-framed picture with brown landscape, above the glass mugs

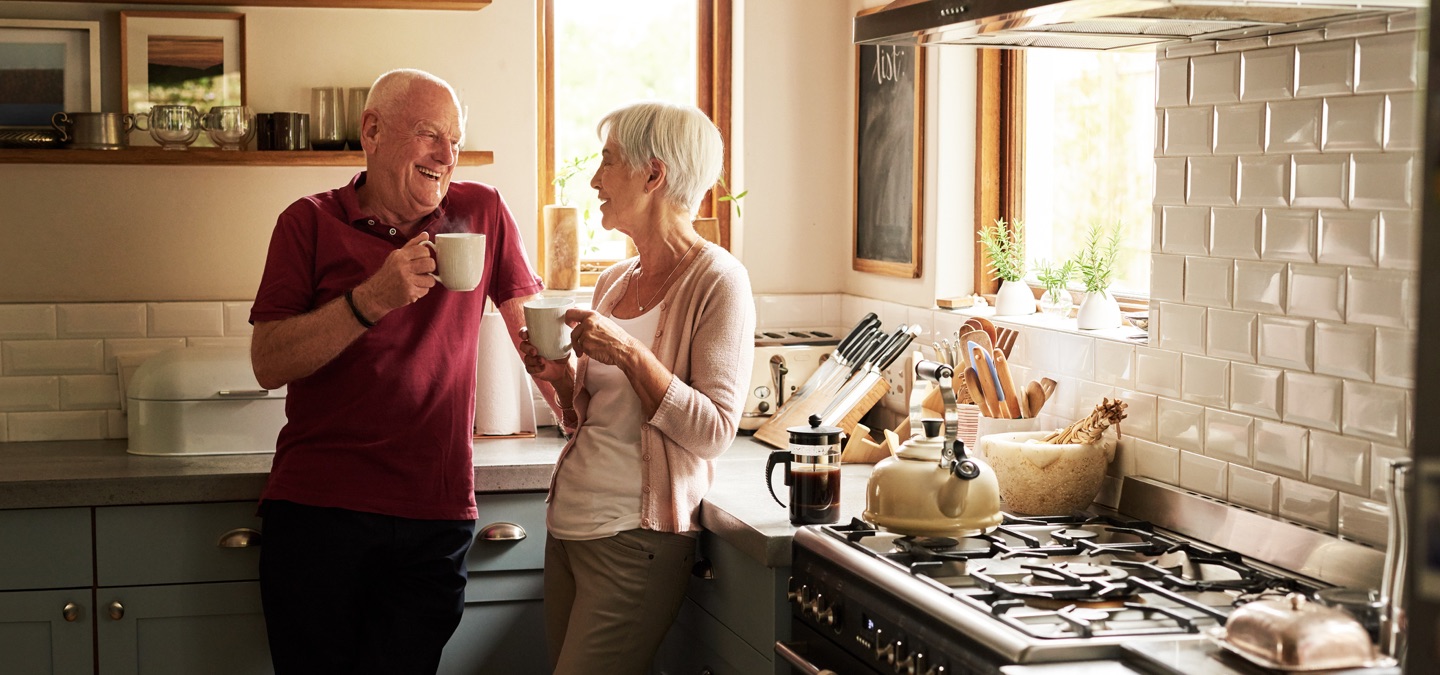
120;12;246;114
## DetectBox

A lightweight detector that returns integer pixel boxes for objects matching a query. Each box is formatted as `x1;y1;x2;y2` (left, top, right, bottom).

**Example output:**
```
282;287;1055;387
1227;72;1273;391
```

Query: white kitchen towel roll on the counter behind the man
475;312;536;436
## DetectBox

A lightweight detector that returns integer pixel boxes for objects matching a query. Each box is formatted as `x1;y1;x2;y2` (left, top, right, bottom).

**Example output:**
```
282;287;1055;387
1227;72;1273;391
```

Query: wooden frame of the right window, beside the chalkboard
971;49;1153;311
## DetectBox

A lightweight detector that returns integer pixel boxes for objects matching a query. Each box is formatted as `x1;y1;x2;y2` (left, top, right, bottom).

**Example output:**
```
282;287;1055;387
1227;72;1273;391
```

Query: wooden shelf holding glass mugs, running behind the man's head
0;148;495;167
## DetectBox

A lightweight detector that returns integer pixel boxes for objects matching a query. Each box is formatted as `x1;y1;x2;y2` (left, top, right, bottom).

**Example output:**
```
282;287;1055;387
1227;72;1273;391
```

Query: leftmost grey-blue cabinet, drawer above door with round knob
0;508;95;675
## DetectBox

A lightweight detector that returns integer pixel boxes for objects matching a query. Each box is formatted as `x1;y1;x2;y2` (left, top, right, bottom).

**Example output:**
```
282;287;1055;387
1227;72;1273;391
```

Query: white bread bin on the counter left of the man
125;347;285;456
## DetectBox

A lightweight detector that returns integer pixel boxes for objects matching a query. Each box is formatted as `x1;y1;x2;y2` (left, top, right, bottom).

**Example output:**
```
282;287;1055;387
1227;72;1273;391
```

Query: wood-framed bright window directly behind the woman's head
537;0;730;282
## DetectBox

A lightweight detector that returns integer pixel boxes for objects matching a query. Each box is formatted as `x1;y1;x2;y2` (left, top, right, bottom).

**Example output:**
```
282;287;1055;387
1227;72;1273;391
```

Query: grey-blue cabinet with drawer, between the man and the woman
439;492;550;675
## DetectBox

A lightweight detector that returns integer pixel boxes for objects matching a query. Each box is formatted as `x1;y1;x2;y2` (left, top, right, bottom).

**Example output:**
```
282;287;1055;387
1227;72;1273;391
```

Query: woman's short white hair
595;102;724;216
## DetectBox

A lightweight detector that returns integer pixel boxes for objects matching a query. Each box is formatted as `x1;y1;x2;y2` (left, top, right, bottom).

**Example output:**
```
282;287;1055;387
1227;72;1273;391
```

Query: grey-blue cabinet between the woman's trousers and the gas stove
652;533;791;675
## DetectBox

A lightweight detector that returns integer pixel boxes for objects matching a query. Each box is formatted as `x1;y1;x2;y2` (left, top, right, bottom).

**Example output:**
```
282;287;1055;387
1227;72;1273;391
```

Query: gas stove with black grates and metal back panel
782;478;1384;675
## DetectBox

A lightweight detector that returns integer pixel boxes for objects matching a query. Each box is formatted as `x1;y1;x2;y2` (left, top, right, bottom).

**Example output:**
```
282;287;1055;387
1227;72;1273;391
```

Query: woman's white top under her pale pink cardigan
546;308;660;541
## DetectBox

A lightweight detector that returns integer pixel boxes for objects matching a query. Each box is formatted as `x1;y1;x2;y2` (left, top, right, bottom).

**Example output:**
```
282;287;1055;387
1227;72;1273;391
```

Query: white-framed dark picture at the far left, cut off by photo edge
0;19;99;128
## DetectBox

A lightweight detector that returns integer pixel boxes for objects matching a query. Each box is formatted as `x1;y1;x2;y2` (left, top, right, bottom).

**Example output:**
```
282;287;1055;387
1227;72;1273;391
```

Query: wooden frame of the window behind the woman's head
536;0;734;288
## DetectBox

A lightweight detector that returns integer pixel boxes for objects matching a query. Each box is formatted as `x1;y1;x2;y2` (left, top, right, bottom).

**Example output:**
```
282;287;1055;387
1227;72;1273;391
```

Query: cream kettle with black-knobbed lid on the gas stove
864;361;1002;537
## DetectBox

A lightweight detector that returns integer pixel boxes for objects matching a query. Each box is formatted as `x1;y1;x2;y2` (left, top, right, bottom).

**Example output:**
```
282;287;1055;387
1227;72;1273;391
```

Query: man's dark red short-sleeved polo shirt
251;171;541;520
